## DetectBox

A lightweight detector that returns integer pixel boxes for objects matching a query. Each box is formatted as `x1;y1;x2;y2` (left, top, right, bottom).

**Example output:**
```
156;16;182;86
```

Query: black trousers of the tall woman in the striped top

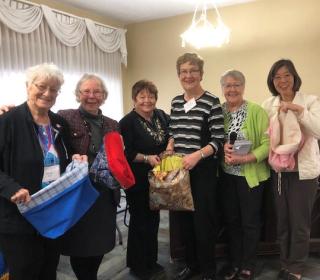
176;159;217;275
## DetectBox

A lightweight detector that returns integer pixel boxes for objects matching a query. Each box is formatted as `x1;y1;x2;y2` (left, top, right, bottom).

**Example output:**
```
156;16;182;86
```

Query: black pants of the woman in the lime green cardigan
220;172;264;270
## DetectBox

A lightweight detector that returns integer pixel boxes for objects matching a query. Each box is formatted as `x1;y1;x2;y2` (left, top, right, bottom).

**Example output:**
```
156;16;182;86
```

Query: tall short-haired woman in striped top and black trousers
167;53;223;280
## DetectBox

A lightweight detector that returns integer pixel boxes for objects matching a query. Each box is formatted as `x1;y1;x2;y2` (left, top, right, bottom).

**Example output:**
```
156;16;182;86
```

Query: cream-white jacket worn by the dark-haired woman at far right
262;92;320;180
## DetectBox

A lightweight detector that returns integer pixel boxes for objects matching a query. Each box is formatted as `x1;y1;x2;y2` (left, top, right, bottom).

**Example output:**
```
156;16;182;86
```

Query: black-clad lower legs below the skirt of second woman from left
70;256;103;280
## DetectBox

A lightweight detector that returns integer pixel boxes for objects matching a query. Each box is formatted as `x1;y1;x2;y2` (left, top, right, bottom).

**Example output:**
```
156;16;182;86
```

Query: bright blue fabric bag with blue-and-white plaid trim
18;161;99;238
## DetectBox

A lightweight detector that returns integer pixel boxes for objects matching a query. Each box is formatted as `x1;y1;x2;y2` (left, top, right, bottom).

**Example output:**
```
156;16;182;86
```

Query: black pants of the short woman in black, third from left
126;189;160;272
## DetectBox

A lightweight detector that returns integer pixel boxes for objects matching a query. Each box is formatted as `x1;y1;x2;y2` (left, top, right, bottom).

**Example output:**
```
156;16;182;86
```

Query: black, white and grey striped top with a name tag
169;91;224;154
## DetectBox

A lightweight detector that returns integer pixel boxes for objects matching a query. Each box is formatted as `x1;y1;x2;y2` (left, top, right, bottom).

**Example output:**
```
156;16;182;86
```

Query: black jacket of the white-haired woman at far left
0;103;71;234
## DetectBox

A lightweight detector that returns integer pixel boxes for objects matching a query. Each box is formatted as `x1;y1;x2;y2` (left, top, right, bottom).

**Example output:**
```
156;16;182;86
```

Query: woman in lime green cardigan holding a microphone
220;70;270;280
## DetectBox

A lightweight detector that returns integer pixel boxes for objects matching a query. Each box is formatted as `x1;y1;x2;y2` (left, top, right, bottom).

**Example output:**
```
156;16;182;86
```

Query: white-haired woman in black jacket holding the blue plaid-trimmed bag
0;64;75;280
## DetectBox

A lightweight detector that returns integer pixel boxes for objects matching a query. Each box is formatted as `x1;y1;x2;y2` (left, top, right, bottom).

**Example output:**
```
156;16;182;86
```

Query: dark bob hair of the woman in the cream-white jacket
267;59;302;96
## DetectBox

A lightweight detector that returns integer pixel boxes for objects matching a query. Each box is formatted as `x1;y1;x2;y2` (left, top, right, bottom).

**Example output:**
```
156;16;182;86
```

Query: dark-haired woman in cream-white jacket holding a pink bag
262;59;320;280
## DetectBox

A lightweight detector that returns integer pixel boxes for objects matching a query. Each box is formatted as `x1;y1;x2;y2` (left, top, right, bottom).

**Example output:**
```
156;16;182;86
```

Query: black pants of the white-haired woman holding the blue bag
0;234;60;280
